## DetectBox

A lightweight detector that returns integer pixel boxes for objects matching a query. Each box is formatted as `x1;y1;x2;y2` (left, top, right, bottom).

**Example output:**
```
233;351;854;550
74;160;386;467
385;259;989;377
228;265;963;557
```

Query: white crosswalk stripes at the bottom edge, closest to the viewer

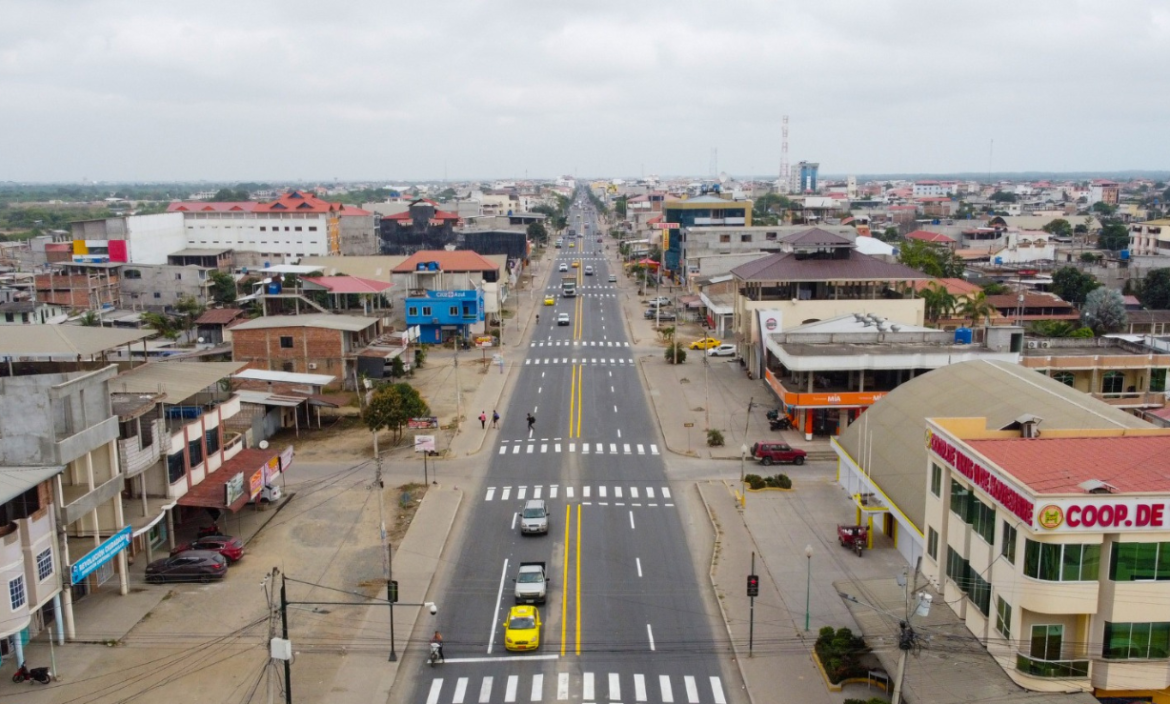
426;672;727;704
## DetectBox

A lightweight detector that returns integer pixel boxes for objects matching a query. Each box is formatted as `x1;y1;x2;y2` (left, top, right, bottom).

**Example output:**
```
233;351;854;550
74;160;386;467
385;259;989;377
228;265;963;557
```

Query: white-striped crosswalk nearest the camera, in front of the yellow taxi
426;672;727;704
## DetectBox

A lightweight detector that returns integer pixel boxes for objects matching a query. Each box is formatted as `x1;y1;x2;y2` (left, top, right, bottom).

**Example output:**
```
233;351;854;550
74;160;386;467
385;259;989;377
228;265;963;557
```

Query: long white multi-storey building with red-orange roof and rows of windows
167;191;377;262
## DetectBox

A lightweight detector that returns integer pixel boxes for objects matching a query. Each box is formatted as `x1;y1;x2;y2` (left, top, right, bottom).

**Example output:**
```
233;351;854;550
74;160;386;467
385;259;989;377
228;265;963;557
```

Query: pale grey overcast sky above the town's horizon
0;0;1170;181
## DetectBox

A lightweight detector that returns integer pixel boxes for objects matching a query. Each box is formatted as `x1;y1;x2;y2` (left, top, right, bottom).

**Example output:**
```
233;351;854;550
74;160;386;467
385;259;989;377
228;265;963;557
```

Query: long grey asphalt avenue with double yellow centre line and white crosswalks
402;198;738;704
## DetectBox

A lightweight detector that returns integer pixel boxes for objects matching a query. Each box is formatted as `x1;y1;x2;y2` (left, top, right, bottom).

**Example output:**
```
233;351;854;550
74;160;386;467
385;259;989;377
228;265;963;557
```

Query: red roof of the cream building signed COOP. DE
966;430;1170;494
